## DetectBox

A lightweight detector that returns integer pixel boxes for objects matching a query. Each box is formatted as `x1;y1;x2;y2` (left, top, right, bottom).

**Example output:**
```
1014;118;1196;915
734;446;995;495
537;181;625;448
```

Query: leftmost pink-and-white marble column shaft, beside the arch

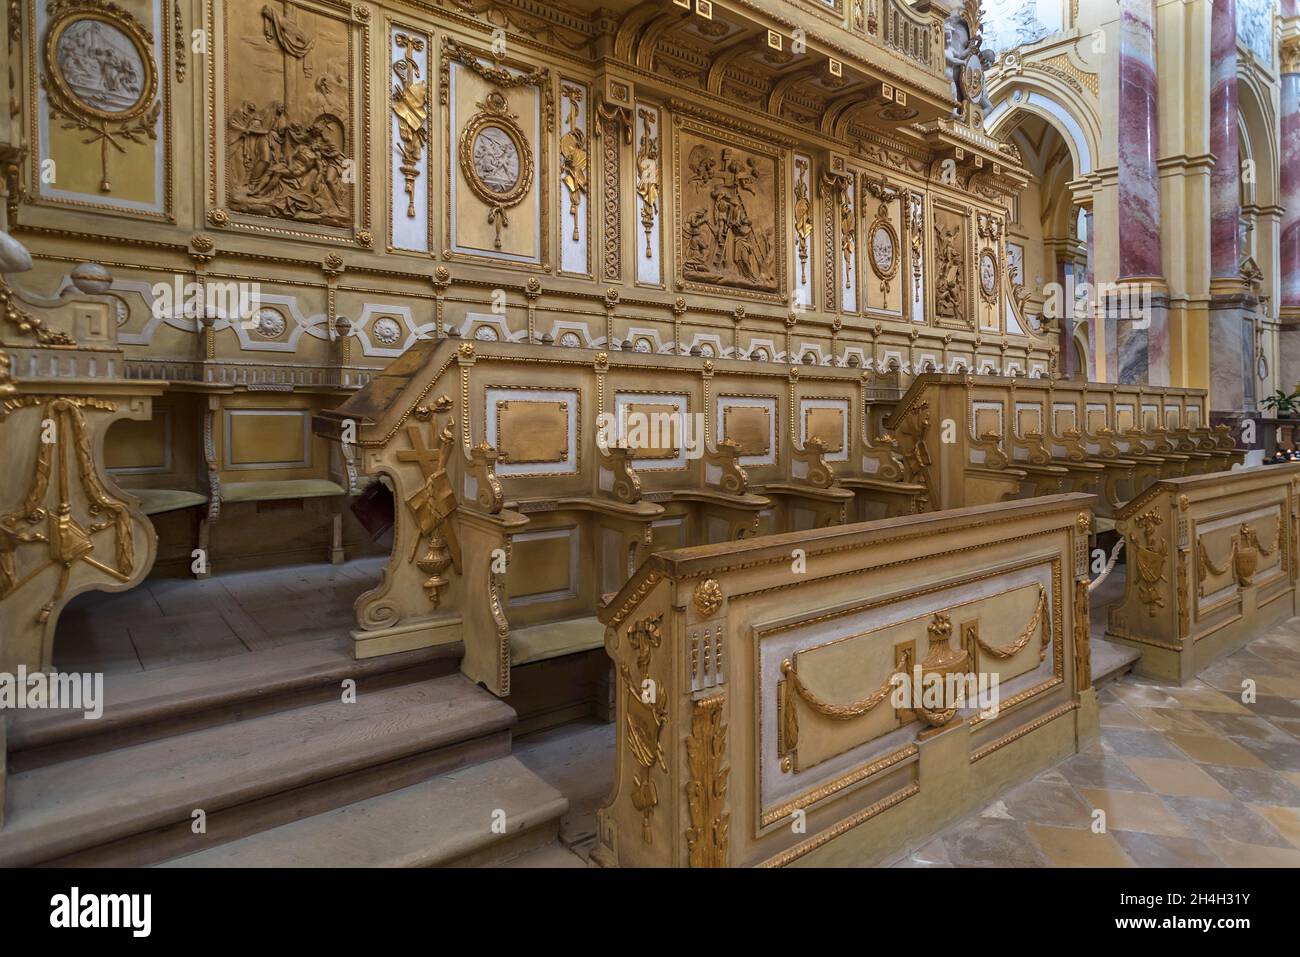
1119;0;1159;280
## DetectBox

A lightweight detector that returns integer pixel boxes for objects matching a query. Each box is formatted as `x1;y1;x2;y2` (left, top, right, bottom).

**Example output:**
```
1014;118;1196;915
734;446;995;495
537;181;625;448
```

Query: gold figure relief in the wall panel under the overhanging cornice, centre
683;143;777;291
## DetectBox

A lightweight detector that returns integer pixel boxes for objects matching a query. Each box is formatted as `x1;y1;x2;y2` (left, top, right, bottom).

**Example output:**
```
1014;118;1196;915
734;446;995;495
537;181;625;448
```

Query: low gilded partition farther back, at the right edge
1106;464;1300;681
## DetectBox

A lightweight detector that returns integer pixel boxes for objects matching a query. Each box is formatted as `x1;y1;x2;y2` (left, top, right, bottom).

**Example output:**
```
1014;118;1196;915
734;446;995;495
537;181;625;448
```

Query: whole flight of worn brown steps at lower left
0;638;568;867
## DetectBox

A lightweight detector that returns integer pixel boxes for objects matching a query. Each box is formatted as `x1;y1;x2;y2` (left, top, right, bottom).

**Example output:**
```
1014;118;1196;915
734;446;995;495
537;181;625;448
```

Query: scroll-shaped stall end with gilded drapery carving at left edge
0;394;157;674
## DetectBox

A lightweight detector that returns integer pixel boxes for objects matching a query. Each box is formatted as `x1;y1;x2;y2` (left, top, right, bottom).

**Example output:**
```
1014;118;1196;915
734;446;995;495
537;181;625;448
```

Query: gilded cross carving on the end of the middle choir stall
397;395;460;609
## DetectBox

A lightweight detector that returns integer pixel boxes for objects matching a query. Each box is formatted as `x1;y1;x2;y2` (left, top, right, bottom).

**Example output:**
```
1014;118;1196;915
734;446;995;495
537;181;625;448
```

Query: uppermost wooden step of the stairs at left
9;637;464;771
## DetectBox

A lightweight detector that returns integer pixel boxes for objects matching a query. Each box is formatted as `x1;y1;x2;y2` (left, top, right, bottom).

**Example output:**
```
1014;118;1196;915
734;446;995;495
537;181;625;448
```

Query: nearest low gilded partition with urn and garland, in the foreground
595;494;1097;867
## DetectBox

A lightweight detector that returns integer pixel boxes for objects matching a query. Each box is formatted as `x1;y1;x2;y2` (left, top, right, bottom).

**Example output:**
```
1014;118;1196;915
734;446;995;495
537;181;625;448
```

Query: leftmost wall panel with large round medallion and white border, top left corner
34;0;170;213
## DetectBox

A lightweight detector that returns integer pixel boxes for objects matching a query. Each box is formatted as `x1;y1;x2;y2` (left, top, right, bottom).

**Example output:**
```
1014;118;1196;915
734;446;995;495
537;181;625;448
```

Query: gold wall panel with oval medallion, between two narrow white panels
443;36;554;263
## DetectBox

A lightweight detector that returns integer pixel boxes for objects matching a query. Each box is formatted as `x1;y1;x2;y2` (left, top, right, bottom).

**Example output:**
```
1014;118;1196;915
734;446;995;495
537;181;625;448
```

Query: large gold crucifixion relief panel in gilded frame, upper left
204;0;371;248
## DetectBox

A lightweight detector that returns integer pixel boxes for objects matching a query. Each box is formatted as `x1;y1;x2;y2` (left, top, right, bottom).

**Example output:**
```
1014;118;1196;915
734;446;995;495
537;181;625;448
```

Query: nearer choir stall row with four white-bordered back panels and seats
315;339;928;694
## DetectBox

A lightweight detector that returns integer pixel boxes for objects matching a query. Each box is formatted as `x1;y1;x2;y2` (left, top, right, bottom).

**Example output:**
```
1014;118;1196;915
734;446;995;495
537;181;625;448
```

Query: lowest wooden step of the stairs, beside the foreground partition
161;757;564;867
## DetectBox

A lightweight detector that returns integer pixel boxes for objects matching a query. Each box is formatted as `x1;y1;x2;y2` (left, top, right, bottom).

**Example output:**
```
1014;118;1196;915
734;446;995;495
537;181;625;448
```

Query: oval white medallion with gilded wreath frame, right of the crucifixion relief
460;90;533;250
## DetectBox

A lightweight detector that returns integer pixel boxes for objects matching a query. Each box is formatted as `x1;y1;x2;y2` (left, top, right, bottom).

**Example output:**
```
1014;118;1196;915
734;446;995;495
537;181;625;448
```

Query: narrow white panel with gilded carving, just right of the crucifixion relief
389;25;430;252
